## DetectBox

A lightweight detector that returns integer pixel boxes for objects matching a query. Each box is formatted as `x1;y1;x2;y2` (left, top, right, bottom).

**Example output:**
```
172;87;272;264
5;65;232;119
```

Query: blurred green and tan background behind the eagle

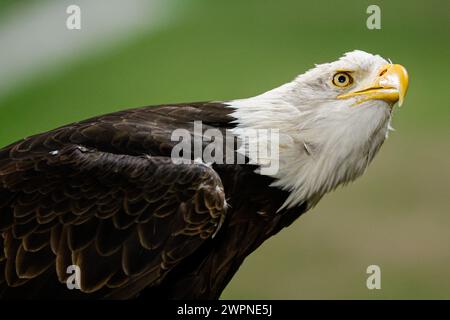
0;0;450;299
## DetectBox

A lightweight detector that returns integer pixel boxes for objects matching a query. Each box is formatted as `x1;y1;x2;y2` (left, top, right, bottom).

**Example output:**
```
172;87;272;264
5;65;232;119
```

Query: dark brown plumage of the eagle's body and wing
0;103;306;299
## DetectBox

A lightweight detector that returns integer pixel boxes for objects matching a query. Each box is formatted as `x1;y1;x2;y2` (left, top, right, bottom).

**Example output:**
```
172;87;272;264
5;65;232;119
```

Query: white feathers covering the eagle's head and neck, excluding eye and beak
230;51;400;209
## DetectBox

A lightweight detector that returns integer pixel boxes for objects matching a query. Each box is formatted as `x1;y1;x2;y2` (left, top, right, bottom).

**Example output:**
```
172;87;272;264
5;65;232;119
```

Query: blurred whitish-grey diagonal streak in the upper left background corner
0;0;171;96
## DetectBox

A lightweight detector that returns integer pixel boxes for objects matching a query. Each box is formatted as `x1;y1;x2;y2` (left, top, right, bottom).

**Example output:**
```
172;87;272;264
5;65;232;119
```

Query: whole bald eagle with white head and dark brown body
0;51;408;299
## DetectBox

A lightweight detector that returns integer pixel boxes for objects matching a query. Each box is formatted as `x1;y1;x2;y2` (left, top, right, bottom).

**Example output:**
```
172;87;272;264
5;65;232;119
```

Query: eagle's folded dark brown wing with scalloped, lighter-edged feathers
0;104;226;298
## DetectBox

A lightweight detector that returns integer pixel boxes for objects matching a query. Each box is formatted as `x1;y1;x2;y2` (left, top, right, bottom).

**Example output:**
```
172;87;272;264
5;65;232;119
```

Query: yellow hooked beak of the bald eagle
337;64;408;106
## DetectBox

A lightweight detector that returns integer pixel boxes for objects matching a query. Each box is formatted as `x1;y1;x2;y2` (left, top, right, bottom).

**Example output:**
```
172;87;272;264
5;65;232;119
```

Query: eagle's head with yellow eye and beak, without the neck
294;50;408;110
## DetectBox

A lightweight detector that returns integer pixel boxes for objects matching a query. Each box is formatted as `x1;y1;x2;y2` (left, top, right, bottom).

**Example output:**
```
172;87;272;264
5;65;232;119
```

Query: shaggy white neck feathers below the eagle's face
229;79;391;210
